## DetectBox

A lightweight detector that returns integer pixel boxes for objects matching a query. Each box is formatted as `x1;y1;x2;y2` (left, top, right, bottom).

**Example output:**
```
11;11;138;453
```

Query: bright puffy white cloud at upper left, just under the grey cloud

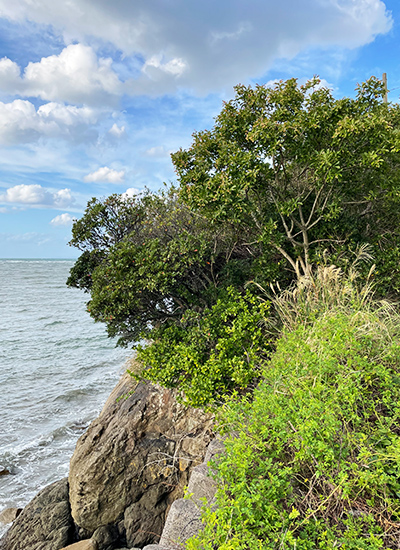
0;44;122;105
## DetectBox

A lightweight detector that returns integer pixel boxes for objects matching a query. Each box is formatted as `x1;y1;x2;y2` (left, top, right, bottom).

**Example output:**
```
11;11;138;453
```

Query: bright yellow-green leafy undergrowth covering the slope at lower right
187;280;400;550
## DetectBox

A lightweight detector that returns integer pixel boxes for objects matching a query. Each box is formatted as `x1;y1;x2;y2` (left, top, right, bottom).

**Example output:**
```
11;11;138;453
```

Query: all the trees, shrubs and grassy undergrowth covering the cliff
68;79;400;550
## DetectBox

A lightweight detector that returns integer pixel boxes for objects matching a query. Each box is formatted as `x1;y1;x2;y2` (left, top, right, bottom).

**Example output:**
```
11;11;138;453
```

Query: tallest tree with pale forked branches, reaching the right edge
172;78;400;278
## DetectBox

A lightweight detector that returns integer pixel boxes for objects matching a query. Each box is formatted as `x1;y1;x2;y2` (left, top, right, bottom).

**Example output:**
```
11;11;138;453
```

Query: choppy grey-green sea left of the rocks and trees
0;260;128;535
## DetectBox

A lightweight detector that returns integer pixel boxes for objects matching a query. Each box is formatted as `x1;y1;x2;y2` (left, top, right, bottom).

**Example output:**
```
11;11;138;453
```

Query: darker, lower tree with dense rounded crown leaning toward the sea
67;189;262;344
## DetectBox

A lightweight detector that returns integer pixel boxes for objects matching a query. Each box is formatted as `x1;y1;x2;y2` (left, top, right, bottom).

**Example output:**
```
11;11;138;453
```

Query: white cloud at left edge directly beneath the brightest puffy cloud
0;99;97;145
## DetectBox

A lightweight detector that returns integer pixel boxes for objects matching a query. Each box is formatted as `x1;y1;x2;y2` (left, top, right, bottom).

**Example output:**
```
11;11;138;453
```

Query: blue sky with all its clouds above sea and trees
0;0;400;258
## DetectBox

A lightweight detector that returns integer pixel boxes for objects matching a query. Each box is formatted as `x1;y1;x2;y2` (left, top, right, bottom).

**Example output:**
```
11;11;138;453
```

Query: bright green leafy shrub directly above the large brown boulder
138;287;269;407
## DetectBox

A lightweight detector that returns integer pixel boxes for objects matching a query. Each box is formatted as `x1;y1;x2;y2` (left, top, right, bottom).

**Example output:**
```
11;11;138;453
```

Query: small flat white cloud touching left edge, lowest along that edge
0;184;75;208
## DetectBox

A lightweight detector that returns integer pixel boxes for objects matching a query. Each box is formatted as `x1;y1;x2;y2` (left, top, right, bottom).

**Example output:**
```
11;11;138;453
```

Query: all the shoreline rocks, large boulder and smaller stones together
0;374;220;550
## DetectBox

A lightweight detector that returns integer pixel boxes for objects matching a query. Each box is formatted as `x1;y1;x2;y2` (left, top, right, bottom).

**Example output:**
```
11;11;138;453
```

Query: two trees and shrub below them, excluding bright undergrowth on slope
68;79;400;416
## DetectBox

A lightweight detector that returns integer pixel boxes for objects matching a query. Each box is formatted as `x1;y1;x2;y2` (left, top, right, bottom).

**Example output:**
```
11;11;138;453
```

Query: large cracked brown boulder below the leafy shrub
69;375;213;547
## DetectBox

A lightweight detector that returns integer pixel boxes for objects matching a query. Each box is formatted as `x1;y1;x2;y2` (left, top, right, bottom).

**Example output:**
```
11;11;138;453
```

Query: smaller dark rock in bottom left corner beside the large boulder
0;479;73;550
